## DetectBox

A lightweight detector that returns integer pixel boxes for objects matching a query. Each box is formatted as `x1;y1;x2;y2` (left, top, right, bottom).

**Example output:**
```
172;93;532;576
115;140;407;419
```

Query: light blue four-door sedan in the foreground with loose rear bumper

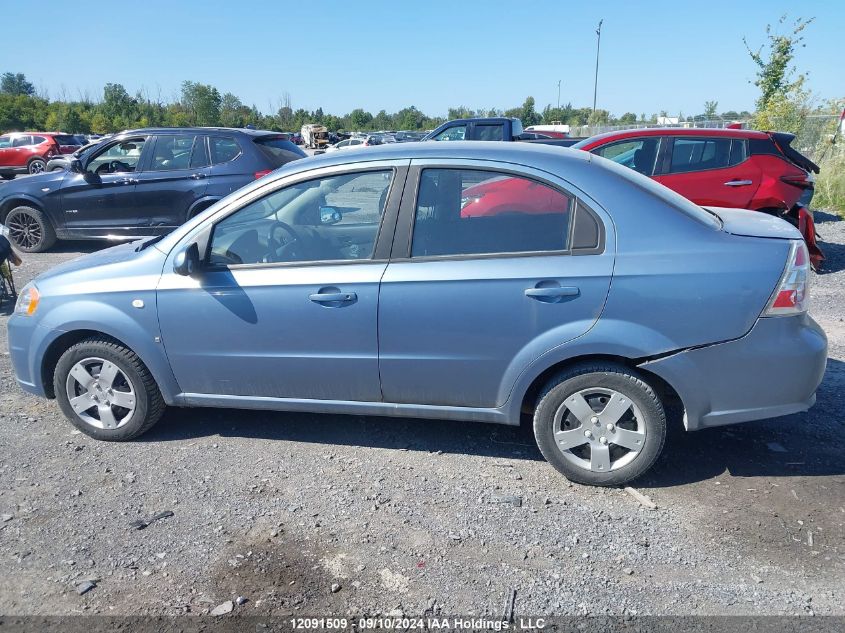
8;143;827;485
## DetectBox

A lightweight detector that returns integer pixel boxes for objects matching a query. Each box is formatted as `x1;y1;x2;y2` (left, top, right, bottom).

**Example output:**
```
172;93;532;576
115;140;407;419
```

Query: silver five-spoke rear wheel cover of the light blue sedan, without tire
553;387;646;473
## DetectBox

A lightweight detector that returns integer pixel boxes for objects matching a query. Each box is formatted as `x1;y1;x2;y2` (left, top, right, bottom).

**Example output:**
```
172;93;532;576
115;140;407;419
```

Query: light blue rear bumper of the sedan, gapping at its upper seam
641;314;827;431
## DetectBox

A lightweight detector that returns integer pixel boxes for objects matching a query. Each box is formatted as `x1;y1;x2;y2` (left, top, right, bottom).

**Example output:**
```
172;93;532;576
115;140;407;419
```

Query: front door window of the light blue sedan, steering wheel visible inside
208;170;393;266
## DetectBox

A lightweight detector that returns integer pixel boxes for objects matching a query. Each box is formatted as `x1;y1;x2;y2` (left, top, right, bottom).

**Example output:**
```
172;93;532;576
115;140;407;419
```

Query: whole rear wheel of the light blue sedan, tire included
534;363;666;486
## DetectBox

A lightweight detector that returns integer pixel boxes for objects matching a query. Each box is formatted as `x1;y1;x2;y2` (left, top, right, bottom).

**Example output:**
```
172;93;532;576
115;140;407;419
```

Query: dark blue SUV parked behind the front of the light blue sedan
0;128;306;253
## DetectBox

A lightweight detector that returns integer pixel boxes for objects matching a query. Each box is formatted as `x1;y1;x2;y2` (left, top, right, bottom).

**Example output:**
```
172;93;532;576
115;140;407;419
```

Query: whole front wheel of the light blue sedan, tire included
53;338;165;442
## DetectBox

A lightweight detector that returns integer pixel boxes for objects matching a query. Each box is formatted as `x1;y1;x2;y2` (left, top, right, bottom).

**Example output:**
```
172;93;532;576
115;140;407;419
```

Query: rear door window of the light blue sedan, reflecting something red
411;169;573;257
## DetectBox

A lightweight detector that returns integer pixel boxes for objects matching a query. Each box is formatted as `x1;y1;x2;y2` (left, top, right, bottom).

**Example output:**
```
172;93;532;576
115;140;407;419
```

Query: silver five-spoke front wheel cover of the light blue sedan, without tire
66;357;137;430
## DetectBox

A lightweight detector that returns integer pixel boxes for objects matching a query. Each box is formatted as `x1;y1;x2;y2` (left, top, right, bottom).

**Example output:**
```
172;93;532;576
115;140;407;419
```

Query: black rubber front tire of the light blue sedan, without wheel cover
53;337;166;442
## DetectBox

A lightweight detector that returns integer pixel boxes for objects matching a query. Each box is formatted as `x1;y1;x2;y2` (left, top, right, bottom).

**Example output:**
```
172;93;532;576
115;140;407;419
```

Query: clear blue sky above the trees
0;0;845;115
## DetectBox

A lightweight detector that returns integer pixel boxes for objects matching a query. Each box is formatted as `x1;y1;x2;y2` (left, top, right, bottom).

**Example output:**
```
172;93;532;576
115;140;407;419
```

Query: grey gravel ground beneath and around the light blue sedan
0;213;845;616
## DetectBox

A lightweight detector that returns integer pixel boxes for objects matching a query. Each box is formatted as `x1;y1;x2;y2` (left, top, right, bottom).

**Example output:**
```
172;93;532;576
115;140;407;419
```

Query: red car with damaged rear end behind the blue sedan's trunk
572;128;824;267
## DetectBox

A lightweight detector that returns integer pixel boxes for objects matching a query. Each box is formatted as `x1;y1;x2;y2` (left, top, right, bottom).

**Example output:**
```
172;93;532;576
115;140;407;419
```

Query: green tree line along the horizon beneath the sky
0;72;750;134
